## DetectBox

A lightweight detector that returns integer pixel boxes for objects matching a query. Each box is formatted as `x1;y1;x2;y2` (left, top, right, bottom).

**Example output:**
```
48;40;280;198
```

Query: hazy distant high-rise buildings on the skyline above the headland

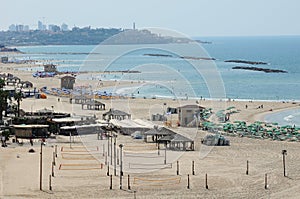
8;21;69;32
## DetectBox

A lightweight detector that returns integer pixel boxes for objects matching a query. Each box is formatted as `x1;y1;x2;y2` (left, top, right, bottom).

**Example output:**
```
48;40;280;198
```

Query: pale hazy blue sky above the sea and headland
0;0;300;37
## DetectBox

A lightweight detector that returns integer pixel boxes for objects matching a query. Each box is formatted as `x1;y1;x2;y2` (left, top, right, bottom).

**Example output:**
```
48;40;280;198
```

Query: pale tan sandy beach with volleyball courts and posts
0;64;300;199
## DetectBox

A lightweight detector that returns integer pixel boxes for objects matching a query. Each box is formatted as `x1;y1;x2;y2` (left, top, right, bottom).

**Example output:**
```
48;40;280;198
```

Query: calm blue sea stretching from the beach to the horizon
13;36;300;125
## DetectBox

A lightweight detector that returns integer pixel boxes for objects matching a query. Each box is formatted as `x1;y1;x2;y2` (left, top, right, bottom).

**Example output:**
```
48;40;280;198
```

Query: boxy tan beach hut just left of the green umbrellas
178;105;205;127
